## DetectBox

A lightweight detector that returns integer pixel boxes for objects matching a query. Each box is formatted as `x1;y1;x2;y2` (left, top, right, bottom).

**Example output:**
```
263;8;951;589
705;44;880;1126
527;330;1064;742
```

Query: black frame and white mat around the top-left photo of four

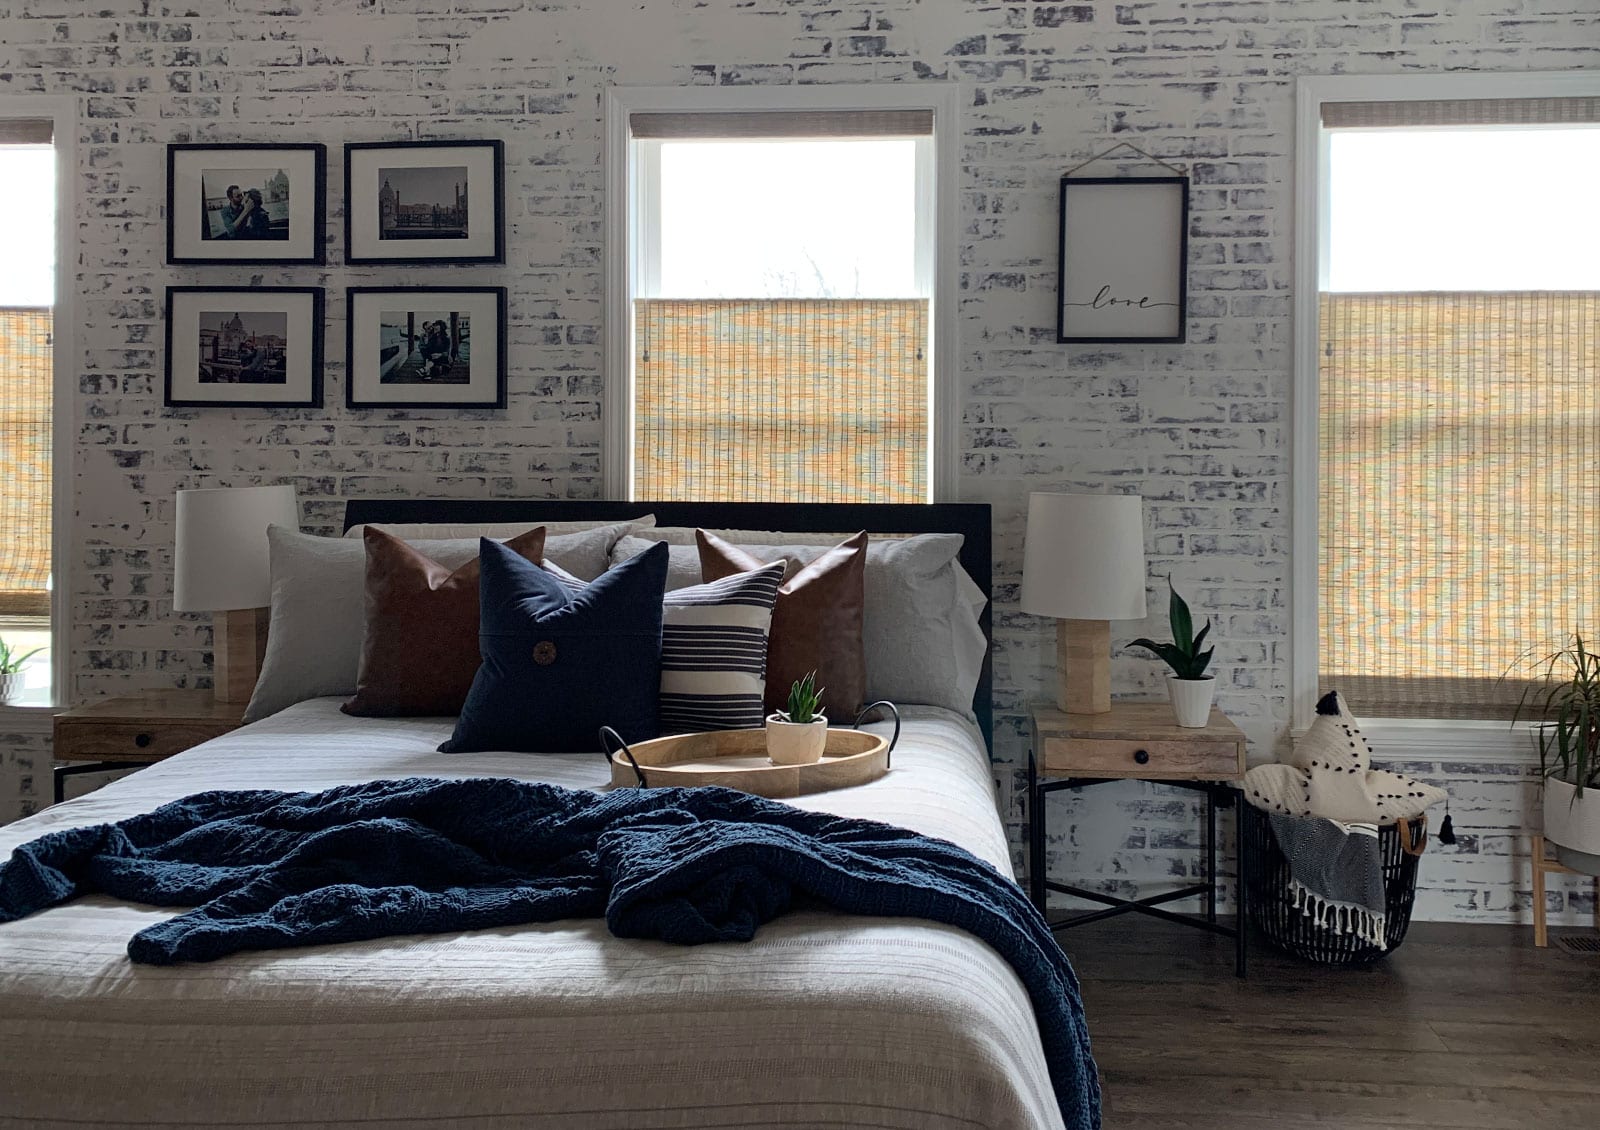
166;146;325;262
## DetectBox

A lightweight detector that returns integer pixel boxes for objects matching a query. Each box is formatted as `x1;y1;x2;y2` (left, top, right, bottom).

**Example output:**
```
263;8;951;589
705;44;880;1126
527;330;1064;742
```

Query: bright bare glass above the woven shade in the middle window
650;139;922;298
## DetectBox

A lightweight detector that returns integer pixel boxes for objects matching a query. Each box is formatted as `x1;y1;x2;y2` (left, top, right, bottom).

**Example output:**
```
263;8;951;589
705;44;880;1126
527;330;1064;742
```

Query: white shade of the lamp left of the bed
173;487;299;611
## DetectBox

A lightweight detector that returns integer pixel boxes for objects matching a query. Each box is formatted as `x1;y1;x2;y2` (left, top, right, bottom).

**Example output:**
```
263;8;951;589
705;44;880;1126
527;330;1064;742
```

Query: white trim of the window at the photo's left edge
0;94;78;733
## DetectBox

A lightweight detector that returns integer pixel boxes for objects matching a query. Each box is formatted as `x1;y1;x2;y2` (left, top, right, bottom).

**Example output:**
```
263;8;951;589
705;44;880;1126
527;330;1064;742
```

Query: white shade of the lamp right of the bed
1022;493;1144;619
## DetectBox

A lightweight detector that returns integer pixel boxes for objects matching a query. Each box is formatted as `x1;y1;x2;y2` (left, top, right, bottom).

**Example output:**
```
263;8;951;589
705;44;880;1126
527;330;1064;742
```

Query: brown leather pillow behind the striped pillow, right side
694;530;867;725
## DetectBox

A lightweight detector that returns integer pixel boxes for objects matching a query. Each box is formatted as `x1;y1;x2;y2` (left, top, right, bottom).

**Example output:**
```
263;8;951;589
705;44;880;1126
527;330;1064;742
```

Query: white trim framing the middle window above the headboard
600;82;962;503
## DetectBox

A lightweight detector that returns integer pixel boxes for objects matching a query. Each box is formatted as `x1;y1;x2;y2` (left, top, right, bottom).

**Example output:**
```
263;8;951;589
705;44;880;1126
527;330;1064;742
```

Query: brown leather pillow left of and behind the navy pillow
341;527;544;715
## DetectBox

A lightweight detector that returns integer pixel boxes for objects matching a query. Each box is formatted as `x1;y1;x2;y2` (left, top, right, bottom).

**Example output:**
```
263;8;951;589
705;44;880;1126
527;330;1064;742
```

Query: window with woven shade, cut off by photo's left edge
0;118;56;704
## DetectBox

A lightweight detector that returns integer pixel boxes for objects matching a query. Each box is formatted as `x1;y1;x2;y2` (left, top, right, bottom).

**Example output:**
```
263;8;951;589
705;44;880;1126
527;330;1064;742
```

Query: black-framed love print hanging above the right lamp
1056;176;1189;344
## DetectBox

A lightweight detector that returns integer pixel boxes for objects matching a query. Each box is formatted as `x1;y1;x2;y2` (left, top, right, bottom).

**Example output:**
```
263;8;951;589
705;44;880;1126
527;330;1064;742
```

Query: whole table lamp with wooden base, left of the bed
173;487;299;703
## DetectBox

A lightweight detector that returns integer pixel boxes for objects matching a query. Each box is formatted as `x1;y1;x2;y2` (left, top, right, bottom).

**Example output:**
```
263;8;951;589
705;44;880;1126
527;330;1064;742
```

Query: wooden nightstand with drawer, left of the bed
51;690;245;803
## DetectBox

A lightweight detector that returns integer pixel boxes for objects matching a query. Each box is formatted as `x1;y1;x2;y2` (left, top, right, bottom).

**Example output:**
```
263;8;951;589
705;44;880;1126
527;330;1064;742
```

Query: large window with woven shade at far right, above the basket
1296;77;1600;722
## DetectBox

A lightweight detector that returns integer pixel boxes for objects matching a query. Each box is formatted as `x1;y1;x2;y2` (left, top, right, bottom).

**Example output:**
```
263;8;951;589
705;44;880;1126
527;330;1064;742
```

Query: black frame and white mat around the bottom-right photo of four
344;287;506;408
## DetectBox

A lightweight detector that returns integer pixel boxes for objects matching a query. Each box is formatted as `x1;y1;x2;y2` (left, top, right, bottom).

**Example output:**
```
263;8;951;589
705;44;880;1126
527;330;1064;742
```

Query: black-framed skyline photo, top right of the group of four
344;141;506;262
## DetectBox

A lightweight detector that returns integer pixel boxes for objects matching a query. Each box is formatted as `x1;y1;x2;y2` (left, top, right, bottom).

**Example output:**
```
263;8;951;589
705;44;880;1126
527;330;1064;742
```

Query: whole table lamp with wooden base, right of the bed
1022;491;1144;714
